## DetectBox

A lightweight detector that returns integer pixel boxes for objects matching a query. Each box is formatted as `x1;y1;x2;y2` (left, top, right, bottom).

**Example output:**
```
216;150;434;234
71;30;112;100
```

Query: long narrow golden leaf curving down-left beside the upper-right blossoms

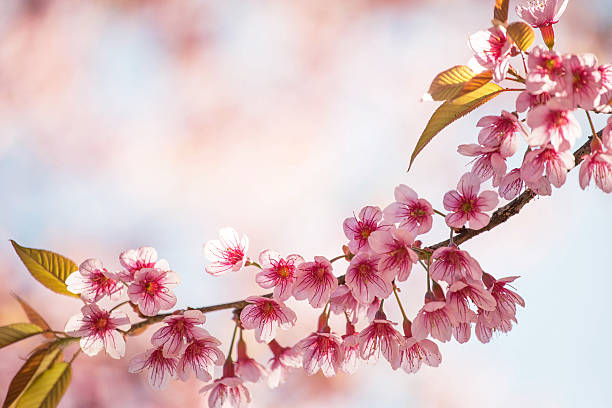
408;82;504;170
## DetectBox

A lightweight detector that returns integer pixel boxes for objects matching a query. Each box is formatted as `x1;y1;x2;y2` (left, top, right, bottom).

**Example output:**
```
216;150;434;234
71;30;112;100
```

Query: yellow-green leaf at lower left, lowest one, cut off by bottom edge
16;361;72;408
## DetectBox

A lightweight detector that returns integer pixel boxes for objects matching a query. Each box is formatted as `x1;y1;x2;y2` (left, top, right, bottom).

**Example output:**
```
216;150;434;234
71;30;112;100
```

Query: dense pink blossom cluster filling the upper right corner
466;0;612;200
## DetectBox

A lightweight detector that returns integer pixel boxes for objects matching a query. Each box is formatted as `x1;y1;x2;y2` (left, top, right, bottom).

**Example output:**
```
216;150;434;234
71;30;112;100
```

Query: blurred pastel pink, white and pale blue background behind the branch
0;0;612;408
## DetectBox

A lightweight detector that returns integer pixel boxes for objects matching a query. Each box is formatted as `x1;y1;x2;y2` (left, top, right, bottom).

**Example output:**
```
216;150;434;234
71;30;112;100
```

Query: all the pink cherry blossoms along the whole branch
50;0;612;408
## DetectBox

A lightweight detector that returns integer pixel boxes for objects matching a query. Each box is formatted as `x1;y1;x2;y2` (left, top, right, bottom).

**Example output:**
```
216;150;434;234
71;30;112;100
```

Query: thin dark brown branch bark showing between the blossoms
125;131;602;336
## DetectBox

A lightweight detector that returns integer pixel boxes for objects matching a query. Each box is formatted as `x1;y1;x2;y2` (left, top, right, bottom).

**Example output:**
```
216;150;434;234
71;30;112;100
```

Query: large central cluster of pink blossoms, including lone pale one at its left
195;196;524;407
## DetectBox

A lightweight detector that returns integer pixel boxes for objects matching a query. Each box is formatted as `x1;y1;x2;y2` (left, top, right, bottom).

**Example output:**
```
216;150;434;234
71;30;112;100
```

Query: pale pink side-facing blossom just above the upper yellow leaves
469;26;513;82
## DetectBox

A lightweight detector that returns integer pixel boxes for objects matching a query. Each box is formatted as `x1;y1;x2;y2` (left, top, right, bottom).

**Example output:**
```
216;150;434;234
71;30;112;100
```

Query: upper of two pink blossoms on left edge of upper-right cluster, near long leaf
476;111;527;158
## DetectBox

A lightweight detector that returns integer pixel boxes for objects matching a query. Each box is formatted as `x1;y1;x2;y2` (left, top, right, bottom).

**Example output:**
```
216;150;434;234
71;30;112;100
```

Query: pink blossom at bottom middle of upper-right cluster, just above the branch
521;145;575;188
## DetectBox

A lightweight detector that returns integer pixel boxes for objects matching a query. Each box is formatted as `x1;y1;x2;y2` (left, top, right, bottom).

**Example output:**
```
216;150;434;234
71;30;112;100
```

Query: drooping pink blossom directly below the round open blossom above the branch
429;245;482;284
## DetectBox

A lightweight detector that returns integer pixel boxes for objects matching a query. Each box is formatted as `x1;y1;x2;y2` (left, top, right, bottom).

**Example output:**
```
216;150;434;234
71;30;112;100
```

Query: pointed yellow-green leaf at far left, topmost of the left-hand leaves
11;240;79;297
